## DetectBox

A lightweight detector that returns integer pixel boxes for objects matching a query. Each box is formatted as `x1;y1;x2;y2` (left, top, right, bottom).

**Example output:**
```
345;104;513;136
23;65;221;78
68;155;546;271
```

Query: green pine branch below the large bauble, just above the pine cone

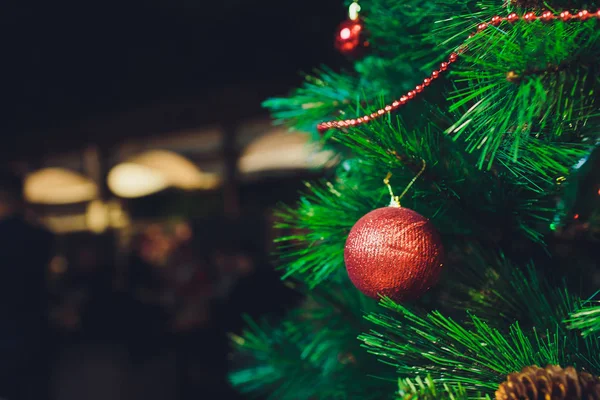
360;299;600;394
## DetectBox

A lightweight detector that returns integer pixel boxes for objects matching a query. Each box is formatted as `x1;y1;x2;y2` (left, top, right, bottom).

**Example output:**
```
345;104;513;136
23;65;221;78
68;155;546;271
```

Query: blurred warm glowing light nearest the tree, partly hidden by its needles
238;131;333;174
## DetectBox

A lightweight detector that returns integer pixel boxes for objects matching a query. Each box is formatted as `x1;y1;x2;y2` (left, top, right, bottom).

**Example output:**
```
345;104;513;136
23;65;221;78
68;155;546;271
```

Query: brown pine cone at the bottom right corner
496;365;600;400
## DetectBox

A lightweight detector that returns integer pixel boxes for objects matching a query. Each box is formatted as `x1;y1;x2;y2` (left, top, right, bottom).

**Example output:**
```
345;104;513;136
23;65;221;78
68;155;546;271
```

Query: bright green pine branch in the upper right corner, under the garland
446;15;600;169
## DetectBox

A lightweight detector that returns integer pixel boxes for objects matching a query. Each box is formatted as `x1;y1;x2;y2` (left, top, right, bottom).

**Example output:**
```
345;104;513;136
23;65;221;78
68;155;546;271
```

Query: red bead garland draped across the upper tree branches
317;10;600;133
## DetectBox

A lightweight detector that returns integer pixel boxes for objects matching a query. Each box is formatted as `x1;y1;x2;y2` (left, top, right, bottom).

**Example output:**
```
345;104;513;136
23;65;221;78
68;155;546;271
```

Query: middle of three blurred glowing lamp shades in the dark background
108;150;219;198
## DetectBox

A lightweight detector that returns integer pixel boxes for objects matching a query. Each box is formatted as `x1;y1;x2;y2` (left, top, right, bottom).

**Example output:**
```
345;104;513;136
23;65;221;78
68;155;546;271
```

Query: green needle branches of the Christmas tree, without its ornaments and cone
232;0;600;400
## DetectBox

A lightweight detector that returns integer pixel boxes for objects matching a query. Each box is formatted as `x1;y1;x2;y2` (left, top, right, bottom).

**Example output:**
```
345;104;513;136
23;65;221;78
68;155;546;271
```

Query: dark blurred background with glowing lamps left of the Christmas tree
0;0;346;400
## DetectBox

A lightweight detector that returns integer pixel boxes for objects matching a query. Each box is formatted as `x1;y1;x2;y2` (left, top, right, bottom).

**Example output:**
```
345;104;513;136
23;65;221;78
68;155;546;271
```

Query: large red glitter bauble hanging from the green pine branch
344;207;444;301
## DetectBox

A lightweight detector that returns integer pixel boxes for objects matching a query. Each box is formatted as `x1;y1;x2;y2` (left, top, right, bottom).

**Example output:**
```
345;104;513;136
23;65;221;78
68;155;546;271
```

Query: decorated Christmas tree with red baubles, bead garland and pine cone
230;0;600;400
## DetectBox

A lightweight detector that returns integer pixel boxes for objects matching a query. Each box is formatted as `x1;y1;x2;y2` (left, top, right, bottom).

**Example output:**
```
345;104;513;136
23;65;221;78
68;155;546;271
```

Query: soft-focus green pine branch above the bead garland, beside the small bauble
263;0;477;139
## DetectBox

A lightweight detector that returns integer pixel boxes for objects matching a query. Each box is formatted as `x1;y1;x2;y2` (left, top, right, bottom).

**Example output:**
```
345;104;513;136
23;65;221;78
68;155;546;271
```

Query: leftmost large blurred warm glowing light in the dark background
24;168;98;205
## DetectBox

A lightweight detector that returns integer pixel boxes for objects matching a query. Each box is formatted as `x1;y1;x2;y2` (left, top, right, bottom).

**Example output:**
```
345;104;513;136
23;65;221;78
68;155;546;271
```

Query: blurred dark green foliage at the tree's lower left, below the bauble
230;281;394;400
